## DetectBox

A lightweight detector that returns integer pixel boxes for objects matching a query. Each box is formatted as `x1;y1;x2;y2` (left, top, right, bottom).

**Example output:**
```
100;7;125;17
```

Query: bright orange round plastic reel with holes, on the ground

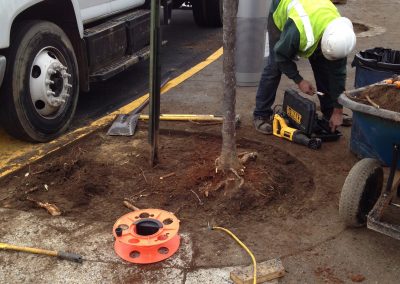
113;209;180;263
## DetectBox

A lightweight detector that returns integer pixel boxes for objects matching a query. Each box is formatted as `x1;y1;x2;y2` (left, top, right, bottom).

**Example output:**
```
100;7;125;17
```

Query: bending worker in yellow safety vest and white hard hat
253;0;356;134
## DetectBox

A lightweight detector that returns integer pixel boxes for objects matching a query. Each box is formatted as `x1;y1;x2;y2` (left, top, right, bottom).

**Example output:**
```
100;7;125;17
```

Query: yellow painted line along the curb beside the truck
0;48;223;178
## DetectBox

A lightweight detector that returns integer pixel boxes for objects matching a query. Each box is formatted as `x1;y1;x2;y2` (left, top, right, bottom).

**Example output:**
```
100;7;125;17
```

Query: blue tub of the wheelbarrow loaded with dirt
338;91;400;169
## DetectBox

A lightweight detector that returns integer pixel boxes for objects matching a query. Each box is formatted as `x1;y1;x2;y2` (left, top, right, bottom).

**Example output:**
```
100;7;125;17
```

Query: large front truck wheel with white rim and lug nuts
0;21;79;142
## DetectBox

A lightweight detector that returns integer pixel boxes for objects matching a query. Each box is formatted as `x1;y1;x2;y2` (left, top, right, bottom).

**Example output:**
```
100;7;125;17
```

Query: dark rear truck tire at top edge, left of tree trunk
191;0;223;28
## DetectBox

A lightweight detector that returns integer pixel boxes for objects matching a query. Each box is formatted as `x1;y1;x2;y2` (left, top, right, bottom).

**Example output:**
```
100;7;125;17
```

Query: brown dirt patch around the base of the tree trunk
0;132;314;227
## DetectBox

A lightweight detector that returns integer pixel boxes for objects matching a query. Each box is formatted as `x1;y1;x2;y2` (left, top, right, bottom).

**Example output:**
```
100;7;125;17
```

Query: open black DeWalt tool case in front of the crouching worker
282;89;342;141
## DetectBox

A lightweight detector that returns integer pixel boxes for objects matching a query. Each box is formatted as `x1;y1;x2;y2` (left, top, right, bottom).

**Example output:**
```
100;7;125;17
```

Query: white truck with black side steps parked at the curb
0;0;222;142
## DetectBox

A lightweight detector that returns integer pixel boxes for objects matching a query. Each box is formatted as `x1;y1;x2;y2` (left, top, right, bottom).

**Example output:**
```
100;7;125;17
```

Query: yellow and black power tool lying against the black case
272;113;322;150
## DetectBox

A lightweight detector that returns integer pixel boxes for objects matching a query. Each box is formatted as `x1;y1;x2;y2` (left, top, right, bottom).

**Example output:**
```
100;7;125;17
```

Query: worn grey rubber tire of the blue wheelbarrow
339;158;383;227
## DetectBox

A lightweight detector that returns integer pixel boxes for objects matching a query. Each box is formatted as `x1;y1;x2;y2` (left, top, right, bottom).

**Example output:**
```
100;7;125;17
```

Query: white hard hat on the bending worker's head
321;17;356;60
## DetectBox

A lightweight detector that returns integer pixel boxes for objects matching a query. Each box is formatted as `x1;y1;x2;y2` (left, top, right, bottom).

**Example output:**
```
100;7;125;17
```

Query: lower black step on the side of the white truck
90;47;150;82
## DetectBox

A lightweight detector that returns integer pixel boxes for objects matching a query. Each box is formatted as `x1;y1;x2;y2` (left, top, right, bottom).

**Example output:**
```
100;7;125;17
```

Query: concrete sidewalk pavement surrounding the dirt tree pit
0;0;400;284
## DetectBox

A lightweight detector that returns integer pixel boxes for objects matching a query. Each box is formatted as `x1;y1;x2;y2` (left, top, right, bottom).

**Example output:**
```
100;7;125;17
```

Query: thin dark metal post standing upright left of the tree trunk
149;0;161;166
